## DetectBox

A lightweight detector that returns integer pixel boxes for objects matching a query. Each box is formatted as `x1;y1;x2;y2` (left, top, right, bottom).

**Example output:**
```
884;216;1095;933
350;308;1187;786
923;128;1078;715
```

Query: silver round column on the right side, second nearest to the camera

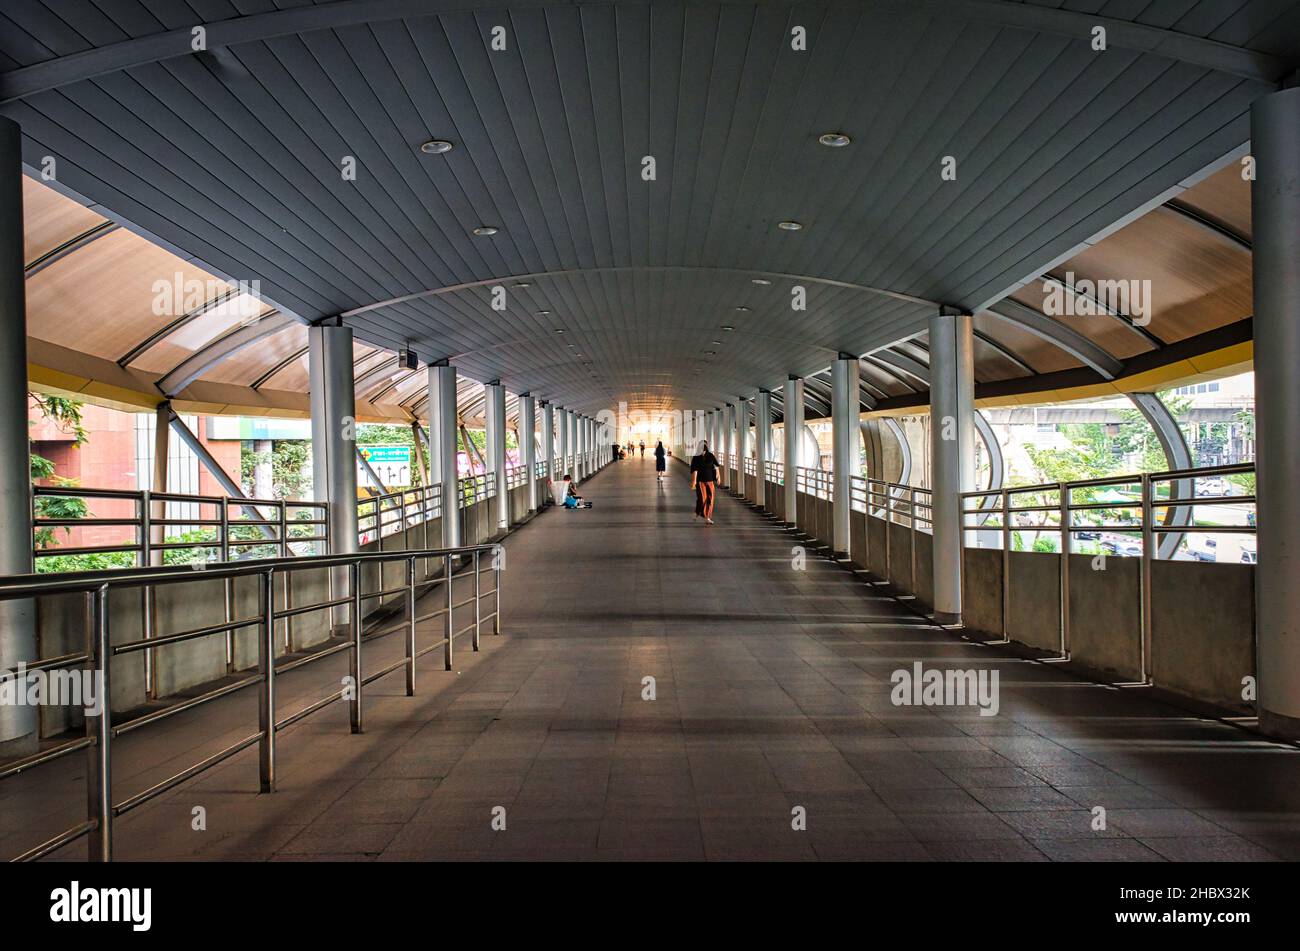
930;312;975;624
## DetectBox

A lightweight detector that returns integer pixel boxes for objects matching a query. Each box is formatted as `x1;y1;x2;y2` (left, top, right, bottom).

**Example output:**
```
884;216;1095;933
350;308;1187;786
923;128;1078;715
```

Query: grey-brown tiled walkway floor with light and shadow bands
10;459;1300;861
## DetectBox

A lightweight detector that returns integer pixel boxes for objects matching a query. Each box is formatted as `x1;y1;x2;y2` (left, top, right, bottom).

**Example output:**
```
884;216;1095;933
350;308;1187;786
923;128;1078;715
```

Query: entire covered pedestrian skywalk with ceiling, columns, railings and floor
0;0;1300;878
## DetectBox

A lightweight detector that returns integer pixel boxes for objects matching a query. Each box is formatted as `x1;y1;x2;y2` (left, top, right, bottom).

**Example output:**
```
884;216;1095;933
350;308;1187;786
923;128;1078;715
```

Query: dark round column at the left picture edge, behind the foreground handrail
0;117;39;759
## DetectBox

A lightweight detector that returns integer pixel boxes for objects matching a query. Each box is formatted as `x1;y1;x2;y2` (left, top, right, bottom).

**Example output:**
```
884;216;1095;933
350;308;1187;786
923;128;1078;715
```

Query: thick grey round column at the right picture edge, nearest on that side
1251;88;1300;739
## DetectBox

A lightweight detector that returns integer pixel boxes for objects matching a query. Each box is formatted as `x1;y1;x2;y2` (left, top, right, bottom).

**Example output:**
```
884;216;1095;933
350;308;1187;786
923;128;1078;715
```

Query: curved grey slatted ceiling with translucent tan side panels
0;0;1300;420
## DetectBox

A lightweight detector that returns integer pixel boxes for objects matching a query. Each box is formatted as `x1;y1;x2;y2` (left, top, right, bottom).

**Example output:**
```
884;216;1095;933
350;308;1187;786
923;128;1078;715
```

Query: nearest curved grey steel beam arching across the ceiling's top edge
0;0;1279;103
